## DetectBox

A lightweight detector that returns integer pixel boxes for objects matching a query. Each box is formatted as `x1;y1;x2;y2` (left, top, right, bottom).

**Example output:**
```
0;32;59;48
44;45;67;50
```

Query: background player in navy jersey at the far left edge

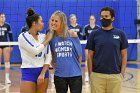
0;13;13;84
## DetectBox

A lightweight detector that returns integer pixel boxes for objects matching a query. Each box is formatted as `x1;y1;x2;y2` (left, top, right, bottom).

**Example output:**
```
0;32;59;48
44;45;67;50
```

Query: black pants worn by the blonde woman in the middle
54;76;82;93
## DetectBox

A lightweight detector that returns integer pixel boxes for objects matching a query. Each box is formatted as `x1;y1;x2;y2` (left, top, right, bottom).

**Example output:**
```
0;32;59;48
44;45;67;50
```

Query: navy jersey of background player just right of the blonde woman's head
69;25;83;40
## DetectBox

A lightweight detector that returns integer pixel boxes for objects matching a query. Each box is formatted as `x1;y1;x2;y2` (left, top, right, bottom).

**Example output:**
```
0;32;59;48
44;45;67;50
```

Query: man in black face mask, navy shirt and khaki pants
86;7;128;93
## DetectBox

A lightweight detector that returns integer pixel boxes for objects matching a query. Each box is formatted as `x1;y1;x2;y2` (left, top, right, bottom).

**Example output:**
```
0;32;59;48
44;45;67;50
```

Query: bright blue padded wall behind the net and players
0;0;137;63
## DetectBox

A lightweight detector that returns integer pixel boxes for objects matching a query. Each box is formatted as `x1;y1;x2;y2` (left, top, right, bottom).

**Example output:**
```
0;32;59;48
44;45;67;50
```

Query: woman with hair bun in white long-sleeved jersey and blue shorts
18;8;53;93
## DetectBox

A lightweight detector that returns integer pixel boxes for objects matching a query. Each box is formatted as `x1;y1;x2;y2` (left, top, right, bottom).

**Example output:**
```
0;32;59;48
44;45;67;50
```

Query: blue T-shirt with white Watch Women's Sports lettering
50;35;82;77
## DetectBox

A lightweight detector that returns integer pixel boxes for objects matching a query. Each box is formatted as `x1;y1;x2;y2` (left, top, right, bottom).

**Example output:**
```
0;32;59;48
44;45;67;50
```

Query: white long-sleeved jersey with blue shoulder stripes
18;32;52;68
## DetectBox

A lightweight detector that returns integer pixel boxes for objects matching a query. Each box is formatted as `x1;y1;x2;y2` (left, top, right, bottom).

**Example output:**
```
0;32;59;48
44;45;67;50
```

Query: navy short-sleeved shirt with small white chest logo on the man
86;28;128;74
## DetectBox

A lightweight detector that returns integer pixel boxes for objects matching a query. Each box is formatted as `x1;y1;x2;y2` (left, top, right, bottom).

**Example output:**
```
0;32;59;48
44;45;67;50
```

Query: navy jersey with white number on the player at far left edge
0;23;13;42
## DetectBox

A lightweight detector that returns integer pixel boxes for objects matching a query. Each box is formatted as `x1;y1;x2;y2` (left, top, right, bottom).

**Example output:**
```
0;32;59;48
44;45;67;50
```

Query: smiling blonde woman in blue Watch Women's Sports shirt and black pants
49;11;82;93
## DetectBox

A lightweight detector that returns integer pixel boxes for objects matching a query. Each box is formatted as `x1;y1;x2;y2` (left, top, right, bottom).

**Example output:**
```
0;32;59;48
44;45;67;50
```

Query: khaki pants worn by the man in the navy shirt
90;72;123;93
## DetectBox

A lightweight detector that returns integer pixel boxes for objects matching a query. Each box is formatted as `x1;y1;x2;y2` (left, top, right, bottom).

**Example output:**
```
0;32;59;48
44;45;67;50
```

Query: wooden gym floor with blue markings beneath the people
0;62;140;93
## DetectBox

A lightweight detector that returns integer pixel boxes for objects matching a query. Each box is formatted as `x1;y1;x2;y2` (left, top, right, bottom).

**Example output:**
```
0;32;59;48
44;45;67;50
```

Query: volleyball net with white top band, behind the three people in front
0;39;140;63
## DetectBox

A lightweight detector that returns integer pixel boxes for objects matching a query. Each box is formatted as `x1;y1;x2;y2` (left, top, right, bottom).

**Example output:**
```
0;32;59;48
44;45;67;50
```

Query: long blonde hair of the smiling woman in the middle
49;10;68;38
